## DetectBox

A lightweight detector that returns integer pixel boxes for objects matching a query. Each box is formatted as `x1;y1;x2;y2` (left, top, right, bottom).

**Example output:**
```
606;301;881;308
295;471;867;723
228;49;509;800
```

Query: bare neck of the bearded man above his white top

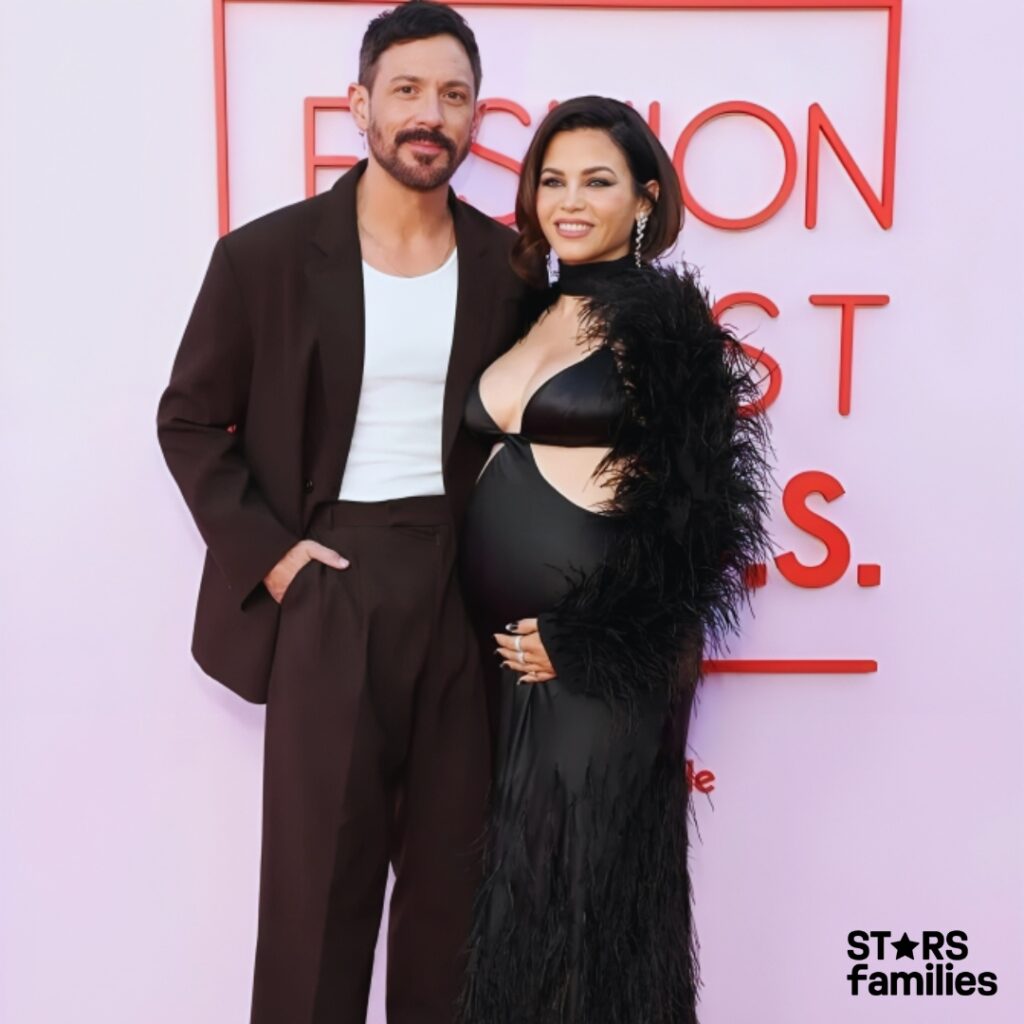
355;160;452;245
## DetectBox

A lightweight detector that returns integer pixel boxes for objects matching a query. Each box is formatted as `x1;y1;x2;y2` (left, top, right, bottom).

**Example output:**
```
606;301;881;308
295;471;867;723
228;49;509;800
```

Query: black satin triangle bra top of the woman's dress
466;345;625;447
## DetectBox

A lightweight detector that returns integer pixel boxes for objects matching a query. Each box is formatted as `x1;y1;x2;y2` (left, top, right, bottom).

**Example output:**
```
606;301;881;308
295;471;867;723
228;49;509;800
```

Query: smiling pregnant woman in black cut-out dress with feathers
460;96;769;1024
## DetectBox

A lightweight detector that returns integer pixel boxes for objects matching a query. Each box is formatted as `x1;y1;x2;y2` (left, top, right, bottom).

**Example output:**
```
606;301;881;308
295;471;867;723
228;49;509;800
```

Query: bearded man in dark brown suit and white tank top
158;0;521;1024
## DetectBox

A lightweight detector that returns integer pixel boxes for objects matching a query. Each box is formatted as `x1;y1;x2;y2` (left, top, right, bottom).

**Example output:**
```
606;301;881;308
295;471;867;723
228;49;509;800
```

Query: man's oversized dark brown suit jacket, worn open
157;161;523;703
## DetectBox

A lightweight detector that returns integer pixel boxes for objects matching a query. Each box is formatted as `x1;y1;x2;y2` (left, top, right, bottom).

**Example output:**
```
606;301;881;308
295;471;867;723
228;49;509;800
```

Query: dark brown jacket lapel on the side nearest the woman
441;199;496;463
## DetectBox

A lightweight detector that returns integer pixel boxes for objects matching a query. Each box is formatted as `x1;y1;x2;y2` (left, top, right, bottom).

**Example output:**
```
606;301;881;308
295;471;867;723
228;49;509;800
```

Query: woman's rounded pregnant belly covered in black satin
461;438;615;631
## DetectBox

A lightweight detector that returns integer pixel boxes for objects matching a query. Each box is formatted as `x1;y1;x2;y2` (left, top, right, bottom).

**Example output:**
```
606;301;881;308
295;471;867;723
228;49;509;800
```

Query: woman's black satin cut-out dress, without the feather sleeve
459;258;695;1024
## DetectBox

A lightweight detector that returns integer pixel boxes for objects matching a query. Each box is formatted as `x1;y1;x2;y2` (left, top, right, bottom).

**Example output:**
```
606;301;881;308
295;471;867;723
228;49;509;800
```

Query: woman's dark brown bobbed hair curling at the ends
512;96;683;288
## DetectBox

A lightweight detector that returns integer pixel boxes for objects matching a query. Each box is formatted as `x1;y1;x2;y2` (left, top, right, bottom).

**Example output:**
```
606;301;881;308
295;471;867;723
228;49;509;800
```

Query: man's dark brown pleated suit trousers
252;497;489;1024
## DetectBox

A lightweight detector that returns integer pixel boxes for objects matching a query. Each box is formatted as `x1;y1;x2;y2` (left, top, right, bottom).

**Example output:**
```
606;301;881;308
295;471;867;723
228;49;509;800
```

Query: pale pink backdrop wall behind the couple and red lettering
0;0;1024;1024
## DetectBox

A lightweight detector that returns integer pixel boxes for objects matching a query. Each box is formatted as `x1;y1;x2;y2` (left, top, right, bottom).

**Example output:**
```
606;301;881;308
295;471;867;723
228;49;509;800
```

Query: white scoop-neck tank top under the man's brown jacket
338;250;459;502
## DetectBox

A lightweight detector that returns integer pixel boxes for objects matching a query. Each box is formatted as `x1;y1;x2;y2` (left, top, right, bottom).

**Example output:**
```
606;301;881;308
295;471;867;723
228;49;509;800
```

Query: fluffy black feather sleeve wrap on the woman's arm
532;265;772;712
